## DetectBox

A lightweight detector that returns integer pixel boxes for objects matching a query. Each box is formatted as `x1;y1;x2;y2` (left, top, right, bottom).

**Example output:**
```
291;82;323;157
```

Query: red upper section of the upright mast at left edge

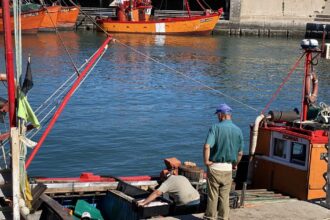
2;0;16;128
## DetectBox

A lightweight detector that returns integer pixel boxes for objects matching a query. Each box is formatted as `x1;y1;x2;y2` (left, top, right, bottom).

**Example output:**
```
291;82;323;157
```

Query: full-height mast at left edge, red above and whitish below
2;0;20;217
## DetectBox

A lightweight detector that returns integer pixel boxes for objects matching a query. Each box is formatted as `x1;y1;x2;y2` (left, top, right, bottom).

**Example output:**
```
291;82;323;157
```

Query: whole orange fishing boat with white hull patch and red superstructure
97;0;222;34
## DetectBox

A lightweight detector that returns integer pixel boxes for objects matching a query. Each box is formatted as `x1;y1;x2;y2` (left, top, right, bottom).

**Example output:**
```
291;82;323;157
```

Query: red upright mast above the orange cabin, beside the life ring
301;50;312;121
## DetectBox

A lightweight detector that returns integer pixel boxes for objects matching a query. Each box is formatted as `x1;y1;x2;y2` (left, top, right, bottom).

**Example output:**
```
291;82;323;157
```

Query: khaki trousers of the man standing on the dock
204;168;232;220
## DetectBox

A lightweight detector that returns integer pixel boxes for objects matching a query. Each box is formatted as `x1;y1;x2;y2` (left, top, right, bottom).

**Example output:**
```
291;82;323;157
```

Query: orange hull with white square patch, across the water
99;14;220;34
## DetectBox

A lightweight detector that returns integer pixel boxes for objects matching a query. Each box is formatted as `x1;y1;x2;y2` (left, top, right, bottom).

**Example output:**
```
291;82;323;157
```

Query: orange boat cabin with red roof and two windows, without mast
252;125;328;200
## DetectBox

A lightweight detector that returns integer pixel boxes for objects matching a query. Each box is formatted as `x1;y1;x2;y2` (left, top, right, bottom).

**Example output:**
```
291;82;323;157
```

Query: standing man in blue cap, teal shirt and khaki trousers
203;104;244;220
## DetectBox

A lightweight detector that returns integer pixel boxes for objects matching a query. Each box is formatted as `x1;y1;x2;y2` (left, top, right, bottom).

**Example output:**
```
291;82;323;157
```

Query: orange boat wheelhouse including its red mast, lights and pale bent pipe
248;40;330;200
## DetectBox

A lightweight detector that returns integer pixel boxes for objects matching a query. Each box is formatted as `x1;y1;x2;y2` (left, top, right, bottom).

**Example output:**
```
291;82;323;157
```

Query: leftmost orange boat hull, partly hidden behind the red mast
0;10;45;33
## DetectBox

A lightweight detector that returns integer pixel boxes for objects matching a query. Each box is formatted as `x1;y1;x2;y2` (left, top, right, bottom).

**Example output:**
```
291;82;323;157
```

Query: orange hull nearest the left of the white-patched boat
57;6;79;28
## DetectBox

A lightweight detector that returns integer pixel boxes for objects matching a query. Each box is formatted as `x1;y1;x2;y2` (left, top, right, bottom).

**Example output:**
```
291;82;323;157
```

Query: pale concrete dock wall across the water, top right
214;0;330;37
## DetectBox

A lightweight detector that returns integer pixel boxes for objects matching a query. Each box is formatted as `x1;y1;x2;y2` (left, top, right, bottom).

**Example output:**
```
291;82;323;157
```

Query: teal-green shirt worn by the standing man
205;120;244;163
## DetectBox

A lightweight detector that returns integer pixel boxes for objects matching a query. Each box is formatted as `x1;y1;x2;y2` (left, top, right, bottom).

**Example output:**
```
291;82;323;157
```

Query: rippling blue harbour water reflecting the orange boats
1;31;330;177
